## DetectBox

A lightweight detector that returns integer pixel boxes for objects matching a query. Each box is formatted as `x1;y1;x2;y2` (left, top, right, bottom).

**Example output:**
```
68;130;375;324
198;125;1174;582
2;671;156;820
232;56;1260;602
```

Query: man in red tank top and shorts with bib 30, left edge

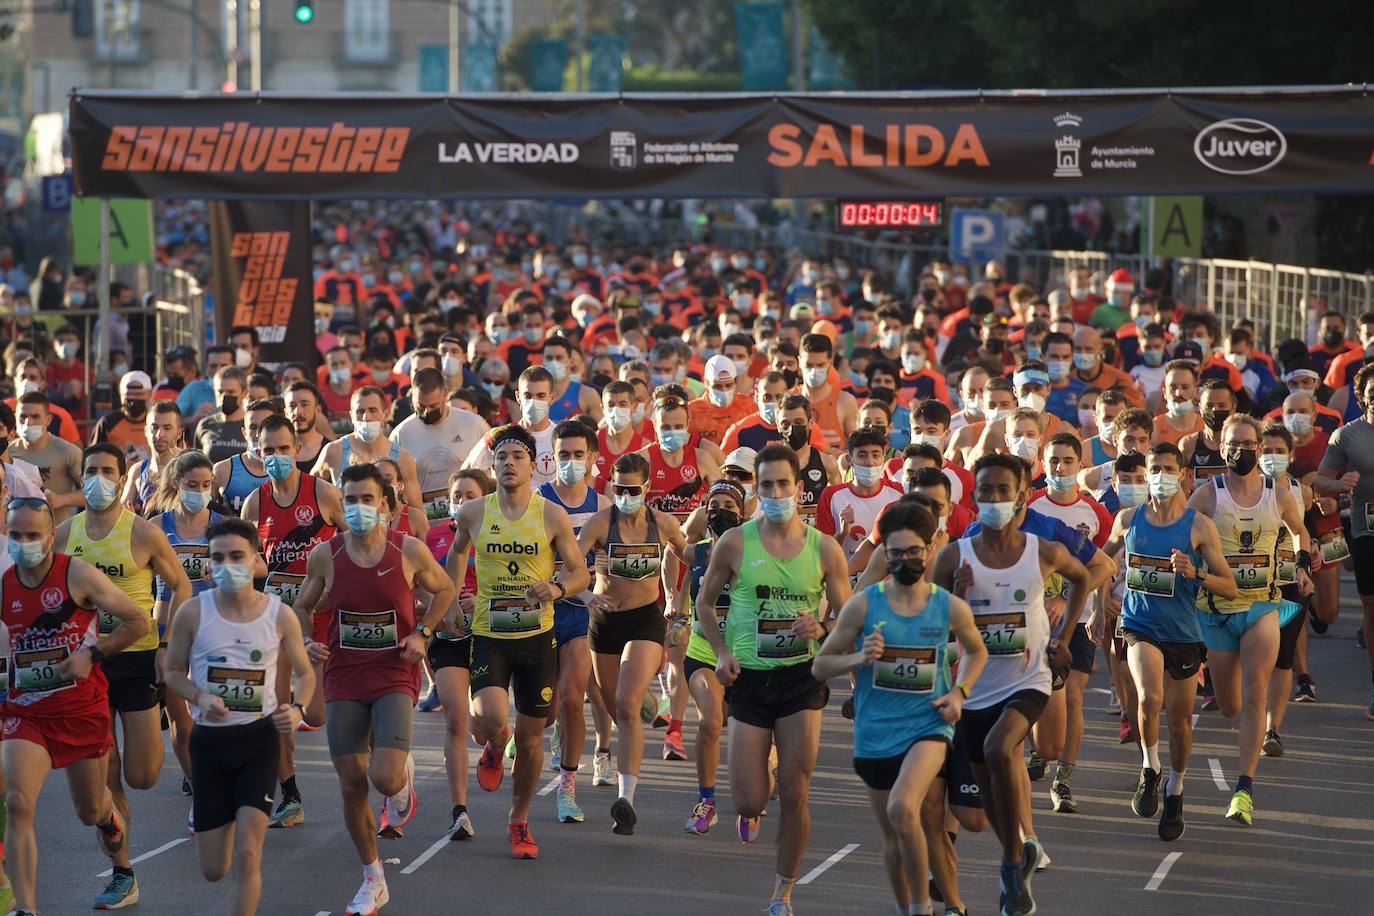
0;499;153;912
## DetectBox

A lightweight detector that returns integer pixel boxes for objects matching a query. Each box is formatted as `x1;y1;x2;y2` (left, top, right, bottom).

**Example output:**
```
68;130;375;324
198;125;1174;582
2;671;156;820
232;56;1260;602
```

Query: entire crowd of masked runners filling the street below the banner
0;222;1374;916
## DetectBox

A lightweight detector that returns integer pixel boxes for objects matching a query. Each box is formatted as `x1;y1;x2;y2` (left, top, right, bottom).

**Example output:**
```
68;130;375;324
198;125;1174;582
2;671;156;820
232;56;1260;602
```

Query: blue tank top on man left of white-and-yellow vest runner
1121;505;1202;643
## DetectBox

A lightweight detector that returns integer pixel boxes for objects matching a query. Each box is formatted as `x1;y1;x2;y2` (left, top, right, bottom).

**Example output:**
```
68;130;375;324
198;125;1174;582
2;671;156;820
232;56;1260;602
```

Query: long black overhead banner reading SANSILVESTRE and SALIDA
70;87;1374;199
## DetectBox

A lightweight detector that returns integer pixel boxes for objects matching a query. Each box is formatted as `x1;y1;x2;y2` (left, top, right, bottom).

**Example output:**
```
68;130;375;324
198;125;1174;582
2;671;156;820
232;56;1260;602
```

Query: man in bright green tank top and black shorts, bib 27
697;444;849;916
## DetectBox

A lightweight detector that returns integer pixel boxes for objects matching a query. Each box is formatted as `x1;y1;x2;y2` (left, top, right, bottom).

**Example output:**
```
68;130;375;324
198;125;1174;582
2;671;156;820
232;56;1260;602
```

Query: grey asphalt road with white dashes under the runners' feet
21;584;1374;916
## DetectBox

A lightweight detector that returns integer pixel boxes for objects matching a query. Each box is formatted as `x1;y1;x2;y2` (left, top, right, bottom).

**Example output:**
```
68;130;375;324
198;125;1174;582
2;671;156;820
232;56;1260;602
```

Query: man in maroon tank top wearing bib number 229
295;464;453;913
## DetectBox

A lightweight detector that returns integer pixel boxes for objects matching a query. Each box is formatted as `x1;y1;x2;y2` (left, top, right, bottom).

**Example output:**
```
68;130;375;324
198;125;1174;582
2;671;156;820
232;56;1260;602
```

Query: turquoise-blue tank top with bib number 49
855;582;954;758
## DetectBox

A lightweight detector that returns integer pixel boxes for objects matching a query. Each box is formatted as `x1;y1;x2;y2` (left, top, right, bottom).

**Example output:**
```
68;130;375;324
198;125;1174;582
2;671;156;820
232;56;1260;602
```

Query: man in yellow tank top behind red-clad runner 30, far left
52;442;191;909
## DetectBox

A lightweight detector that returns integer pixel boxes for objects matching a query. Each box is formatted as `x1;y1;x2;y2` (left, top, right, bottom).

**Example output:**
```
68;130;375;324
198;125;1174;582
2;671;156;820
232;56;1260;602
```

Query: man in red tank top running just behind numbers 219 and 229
240;415;344;827
